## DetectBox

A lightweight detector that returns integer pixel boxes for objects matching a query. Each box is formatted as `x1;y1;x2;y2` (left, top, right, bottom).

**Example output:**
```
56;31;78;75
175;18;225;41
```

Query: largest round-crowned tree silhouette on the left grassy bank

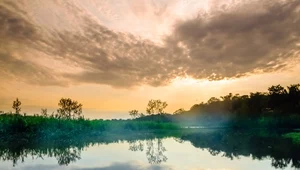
57;98;82;119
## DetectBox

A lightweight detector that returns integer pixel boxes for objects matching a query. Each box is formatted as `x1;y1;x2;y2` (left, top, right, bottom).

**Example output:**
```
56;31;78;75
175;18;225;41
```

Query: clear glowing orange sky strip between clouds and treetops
0;67;300;118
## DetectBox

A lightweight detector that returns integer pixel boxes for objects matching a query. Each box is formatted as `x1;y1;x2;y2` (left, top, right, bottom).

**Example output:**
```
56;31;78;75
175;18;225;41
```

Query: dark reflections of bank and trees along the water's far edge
0;130;300;168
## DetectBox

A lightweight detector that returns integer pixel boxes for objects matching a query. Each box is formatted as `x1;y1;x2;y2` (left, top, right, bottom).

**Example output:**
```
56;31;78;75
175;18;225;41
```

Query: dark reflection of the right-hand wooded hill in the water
182;131;300;168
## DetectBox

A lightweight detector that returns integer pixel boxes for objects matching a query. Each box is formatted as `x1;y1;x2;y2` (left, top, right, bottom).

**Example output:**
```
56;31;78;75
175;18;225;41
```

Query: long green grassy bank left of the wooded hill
0;114;179;140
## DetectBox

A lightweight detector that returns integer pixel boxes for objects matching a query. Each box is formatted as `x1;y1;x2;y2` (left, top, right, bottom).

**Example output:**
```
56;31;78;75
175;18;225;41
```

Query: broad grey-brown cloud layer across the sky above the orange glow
0;0;300;87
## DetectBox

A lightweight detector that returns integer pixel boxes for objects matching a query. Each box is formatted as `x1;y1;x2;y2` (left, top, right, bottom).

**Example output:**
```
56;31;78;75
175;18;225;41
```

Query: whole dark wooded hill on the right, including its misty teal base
175;84;300;128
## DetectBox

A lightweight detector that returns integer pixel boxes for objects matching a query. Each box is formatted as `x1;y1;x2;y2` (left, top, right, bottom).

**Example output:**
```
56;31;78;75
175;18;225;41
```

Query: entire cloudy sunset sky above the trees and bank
0;0;300;119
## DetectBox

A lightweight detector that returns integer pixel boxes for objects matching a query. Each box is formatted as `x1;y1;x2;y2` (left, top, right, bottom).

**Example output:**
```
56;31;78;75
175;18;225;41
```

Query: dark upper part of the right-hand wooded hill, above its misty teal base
188;84;300;117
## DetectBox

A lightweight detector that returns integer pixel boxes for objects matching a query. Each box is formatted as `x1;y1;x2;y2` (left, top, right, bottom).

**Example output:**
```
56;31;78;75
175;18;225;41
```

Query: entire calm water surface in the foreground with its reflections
0;129;300;170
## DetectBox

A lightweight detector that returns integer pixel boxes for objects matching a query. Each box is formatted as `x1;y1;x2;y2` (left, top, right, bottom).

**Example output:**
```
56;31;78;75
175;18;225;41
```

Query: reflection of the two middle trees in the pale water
129;138;168;164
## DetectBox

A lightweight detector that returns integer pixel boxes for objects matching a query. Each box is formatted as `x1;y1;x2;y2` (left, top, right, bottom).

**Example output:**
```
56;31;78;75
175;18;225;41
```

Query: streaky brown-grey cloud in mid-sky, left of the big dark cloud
34;13;185;87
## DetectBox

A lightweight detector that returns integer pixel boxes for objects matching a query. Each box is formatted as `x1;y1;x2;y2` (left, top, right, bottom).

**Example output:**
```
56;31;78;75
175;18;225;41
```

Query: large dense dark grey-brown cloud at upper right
172;0;300;79
